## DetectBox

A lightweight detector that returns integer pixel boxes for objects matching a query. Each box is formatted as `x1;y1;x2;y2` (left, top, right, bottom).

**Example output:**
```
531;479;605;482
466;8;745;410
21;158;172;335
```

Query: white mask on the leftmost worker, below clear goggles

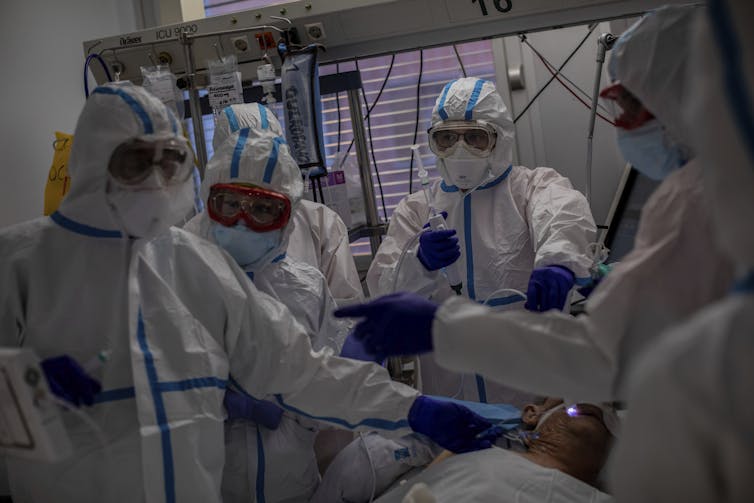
106;174;194;238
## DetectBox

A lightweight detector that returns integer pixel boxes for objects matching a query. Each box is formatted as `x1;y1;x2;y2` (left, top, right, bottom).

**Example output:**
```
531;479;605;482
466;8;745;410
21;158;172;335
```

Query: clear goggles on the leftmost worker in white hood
107;136;193;186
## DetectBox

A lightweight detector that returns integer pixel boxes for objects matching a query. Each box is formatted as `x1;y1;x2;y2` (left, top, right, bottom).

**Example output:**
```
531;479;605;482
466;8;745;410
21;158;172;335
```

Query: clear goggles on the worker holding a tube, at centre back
427;120;497;157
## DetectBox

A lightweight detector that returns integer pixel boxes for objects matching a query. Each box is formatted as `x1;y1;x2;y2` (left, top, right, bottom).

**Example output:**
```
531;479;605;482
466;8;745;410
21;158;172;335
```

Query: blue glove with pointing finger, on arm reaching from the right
333;292;438;359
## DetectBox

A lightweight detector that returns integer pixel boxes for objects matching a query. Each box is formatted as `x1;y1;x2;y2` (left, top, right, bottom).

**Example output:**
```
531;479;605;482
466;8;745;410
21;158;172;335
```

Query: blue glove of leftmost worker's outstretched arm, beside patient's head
408;396;503;453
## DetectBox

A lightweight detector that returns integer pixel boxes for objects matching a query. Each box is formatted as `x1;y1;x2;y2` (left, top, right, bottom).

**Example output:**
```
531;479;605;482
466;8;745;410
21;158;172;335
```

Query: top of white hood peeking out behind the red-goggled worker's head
212;103;283;151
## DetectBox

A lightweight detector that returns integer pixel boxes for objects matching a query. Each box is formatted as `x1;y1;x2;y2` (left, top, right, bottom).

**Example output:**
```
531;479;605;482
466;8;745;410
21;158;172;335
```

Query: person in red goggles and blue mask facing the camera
184;127;360;503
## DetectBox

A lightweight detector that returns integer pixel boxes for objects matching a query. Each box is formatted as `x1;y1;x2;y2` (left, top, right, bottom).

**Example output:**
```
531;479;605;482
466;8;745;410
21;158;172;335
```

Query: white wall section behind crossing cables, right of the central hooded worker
498;23;625;224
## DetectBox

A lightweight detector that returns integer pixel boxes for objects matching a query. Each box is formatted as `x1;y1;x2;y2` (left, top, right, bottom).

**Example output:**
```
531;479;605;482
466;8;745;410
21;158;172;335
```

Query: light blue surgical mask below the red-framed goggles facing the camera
210;222;283;267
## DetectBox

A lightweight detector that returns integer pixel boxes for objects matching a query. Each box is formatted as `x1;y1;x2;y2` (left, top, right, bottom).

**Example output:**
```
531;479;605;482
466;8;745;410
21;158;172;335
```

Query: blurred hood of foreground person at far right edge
687;0;754;272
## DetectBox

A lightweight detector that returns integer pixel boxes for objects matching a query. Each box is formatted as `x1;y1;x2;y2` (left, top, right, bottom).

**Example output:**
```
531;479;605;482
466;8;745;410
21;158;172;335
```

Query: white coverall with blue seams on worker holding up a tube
367;78;596;406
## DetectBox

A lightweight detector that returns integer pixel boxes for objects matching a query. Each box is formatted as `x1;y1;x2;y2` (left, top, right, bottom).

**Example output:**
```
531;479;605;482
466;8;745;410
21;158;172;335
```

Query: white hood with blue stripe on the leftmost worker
58;82;187;231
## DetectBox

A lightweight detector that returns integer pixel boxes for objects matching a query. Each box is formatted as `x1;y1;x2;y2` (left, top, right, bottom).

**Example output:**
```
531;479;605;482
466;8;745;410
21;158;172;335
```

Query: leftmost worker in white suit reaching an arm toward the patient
0;83;502;502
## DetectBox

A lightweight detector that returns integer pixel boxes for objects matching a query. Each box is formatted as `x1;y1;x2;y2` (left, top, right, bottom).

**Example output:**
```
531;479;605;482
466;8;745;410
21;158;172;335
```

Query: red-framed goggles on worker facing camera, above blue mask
207;183;291;232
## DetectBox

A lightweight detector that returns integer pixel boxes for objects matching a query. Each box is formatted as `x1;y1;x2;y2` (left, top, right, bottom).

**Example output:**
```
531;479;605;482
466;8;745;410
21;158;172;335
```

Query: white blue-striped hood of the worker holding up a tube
432;77;515;184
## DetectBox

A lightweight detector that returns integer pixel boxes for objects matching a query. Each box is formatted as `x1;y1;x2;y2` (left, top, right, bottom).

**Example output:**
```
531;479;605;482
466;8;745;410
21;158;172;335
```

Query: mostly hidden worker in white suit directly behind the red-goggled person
212;103;364;306
